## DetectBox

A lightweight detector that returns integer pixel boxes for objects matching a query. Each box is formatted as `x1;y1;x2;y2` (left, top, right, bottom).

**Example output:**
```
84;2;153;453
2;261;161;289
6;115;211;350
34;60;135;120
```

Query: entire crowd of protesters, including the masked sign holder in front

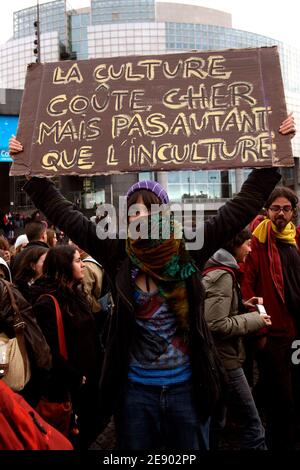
0;116;300;451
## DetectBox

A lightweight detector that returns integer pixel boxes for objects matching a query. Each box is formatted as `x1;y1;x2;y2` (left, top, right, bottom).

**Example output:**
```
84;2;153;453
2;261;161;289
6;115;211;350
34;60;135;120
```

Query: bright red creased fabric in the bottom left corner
0;380;73;450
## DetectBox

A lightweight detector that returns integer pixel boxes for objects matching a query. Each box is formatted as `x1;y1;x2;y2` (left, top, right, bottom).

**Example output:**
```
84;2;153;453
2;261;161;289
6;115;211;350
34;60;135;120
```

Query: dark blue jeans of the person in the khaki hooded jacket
226;368;266;450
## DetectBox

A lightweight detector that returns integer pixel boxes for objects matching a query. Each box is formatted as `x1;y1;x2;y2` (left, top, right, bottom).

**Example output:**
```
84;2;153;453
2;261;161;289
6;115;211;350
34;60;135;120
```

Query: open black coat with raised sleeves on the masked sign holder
25;168;280;425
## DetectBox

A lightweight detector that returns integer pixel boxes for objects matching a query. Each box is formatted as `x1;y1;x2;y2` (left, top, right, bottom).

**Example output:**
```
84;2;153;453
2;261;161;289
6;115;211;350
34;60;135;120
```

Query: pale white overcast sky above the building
0;0;300;49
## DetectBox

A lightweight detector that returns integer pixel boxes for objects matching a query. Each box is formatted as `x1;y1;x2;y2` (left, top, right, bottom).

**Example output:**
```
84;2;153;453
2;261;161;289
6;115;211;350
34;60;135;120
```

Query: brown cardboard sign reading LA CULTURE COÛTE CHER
11;47;293;175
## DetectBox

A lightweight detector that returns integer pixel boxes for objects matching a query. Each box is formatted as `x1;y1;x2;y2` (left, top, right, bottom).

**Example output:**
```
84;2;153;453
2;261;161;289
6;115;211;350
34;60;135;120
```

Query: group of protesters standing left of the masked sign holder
0;212;102;448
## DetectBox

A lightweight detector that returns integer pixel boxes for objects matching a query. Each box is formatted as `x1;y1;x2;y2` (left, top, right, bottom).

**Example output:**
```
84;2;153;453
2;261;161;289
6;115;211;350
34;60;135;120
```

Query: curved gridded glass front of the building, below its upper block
84;6;300;202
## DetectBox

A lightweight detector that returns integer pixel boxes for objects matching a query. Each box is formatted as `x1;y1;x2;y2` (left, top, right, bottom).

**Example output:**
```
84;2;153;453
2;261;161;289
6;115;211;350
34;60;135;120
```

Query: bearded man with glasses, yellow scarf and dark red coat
242;187;300;450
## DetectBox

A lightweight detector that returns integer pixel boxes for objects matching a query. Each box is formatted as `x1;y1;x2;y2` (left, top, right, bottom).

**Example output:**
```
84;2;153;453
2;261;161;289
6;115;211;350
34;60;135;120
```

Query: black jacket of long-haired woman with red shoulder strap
31;278;100;401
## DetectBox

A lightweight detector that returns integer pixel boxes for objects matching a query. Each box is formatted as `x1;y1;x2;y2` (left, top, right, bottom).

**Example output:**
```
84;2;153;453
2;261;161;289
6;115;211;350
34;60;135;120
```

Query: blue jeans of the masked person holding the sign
115;382;209;451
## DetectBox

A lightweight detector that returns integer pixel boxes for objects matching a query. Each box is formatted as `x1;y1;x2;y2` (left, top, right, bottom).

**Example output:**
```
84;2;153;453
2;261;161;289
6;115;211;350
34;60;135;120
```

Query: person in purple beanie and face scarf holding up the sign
10;113;294;452
